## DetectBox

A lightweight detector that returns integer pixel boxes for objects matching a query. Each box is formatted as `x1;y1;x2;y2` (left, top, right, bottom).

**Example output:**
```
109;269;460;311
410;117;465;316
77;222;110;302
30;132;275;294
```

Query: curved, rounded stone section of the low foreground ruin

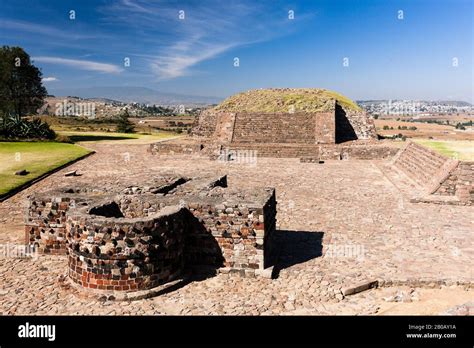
66;202;185;292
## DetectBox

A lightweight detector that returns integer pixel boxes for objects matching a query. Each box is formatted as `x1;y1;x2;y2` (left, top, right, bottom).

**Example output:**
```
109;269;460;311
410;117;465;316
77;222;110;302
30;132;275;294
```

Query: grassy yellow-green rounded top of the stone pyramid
214;88;361;113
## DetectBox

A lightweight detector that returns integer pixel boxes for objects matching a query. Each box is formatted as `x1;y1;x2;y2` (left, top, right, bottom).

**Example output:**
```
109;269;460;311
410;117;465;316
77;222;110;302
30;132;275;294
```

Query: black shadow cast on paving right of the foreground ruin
272;230;324;278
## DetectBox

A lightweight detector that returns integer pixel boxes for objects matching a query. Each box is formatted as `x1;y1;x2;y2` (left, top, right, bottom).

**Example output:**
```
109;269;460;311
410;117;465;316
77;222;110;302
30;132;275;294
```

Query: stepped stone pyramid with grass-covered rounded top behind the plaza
150;88;395;162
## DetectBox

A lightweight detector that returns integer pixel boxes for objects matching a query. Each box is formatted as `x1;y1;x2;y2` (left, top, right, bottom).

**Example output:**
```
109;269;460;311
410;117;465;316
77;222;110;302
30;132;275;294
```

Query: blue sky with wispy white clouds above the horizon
0;0;474;102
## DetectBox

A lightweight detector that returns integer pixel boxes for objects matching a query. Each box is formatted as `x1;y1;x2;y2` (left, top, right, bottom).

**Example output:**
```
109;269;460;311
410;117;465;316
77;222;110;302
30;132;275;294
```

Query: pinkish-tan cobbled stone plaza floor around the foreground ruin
0;144;474;315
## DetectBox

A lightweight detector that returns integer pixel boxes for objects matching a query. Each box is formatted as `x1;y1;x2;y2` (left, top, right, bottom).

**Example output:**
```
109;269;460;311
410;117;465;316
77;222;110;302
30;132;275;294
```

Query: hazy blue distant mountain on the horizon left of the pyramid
49;87;221;107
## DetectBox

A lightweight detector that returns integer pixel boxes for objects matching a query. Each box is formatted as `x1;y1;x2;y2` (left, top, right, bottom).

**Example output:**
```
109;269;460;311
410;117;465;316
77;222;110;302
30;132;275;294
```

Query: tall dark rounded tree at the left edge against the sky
0;46;47;117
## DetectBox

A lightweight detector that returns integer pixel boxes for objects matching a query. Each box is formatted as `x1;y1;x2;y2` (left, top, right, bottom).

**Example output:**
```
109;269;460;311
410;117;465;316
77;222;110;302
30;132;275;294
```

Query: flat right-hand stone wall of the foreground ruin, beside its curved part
183;191;276;277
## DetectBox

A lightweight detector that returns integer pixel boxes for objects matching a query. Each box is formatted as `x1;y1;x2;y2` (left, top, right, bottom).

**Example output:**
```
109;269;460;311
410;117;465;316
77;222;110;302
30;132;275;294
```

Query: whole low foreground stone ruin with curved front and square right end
25;176;276;291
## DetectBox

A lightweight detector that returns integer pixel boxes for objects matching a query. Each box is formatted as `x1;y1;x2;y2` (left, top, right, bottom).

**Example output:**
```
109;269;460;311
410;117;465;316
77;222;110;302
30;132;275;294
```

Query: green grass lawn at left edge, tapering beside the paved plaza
0;142;91;197
